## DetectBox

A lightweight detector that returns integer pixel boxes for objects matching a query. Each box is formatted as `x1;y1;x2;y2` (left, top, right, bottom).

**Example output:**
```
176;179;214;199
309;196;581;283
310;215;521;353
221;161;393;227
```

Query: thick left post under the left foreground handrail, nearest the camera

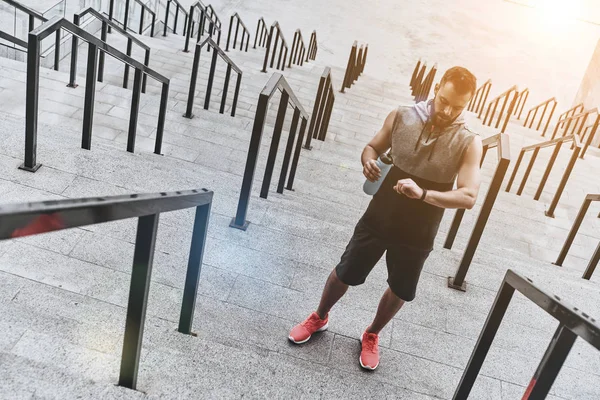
119;214;159;389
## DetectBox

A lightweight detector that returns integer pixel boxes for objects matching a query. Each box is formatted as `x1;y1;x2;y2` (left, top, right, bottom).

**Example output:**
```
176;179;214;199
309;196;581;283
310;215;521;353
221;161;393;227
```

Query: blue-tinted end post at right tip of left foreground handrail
177;203;211;335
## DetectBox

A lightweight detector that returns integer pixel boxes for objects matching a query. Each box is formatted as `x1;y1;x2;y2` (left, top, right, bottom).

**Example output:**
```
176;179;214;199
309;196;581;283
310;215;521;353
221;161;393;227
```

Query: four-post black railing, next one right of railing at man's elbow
506;135;581;217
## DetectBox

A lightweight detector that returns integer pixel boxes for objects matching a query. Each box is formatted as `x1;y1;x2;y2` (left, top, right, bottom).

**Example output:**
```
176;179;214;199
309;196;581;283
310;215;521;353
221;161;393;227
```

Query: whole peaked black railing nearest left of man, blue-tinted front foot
229;72;309;231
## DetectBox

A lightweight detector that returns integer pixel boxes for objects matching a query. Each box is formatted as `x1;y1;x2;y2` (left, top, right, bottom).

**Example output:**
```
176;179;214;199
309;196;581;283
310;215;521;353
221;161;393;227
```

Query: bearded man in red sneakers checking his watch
289;67;483;370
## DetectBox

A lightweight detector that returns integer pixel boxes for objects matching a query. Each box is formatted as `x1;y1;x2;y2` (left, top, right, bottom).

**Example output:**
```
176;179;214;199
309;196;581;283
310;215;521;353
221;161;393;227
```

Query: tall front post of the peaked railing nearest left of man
229;94;269;231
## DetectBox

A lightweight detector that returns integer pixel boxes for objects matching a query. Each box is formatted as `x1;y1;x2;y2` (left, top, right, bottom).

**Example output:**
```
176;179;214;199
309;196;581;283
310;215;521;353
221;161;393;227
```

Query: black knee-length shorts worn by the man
335;220;431;301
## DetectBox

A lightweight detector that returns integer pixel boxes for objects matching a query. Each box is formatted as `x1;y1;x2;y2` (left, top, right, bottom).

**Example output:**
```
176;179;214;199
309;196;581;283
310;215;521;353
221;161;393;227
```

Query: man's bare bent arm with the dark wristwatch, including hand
394;136;483;210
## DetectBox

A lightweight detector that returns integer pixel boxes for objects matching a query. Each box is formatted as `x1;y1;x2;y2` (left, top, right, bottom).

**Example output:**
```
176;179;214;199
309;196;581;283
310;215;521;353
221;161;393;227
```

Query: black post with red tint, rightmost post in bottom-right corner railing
524;324;577;400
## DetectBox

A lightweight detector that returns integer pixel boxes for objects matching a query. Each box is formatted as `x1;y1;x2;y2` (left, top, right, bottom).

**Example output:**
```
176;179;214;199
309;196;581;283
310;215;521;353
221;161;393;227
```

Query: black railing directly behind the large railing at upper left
67;7;150;93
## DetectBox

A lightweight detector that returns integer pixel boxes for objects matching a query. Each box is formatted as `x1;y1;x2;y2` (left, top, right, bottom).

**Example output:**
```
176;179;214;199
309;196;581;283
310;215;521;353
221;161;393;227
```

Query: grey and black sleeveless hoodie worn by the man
361;100;476;251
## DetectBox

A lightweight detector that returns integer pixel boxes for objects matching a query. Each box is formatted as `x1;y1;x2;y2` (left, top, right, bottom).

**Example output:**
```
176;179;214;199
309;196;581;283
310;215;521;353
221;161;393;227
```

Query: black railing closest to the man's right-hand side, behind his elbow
444;133;510;292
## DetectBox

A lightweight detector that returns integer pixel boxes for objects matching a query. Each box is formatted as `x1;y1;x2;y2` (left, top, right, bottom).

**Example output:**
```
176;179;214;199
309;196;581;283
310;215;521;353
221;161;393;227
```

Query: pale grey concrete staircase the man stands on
0;10;600;400
